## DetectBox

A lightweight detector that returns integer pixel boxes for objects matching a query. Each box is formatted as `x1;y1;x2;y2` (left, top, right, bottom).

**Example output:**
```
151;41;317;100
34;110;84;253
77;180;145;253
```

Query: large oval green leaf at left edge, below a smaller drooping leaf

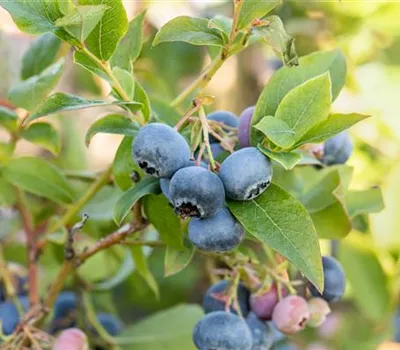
3;157;75;203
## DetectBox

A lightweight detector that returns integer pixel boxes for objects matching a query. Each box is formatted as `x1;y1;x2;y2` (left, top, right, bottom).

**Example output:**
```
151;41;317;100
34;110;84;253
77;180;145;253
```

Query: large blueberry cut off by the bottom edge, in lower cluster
193;311;252;350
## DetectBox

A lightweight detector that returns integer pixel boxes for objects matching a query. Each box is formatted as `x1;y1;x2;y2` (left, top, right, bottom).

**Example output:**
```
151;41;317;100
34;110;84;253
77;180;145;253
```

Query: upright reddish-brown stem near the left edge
15;188;39;306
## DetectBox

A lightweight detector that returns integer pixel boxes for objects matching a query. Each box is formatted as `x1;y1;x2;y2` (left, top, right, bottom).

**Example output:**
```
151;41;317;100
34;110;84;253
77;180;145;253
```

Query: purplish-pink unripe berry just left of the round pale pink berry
250;284;287;321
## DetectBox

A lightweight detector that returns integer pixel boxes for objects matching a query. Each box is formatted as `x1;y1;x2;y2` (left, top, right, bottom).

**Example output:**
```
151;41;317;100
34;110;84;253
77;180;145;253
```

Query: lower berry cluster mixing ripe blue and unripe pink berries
193;257;345;350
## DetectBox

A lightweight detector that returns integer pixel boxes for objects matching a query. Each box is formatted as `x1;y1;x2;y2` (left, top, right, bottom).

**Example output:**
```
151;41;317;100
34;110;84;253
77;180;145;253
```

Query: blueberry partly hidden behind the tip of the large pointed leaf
309;256;346;303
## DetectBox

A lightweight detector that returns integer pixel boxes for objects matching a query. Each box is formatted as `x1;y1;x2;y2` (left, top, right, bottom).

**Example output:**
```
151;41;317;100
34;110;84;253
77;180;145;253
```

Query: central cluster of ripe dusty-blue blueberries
132;112;272;252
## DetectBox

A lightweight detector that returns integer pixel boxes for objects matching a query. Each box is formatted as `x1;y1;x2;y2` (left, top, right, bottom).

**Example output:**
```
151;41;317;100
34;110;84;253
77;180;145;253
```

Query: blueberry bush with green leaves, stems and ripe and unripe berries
0;0;395;350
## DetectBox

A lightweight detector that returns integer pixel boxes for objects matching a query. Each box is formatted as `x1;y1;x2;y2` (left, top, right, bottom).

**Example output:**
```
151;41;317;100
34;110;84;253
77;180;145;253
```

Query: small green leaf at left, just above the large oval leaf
21;123;61;155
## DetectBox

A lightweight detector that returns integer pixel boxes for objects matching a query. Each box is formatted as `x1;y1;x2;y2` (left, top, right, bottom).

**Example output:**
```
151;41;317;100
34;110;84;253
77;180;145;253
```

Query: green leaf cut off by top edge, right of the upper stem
238;0;281;29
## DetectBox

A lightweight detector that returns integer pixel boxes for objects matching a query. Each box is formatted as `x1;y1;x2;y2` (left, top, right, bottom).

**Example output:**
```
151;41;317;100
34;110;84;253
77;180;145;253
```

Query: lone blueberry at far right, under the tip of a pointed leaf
321;131;353;165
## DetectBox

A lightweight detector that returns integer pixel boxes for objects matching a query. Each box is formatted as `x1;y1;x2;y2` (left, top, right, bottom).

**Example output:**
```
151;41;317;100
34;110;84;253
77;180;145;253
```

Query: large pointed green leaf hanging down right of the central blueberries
228;184;323;290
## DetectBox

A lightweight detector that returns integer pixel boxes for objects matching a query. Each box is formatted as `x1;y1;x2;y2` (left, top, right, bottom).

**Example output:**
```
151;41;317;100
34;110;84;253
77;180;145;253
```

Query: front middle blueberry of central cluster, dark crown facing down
169;166;225;218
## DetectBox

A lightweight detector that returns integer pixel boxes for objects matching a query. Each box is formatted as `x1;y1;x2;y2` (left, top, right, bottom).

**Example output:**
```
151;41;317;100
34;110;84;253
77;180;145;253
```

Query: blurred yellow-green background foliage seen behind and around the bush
0;0;400;350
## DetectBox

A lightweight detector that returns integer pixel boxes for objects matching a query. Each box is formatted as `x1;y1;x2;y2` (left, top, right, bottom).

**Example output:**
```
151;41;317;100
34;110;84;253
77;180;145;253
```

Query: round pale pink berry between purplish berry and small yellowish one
272;295;310;334
